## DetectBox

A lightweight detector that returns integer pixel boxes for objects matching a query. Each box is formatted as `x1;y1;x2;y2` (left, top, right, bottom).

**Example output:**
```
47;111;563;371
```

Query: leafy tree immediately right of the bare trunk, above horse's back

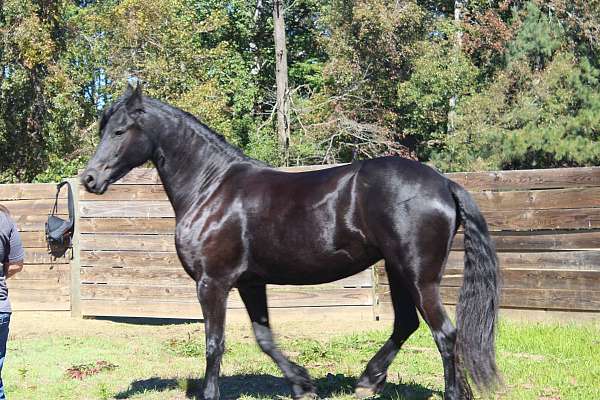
293;0;427;162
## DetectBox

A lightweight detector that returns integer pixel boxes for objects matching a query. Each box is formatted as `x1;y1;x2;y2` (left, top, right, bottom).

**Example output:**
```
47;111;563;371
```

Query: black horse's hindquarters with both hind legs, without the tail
357;175;466;399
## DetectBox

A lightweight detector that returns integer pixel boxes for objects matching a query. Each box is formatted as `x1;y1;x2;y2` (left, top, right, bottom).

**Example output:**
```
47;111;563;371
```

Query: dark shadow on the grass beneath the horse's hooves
115;374;442;400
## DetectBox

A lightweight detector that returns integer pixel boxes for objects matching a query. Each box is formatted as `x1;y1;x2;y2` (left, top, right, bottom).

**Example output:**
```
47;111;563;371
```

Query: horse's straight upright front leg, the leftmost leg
196;277;229;400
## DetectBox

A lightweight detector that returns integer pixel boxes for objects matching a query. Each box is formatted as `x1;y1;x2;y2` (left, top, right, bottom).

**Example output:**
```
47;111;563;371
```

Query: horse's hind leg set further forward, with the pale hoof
355;262;419;398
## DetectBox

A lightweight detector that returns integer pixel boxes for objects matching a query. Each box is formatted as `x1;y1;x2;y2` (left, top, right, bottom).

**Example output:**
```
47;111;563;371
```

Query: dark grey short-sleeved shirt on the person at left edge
0;211;25;313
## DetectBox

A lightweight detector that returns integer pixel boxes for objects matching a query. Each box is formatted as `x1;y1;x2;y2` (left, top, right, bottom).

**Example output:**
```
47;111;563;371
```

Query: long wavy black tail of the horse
450;181;501;392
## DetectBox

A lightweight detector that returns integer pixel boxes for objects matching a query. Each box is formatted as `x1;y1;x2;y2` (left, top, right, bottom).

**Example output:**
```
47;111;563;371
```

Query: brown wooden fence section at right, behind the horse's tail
376;167;600;317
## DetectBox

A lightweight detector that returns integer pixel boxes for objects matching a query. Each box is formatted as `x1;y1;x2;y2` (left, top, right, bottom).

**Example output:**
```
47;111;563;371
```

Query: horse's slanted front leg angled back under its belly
238;285;317;400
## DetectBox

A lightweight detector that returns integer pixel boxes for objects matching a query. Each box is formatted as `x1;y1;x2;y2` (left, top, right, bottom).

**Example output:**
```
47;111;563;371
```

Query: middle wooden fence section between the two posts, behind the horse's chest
79;169;374;318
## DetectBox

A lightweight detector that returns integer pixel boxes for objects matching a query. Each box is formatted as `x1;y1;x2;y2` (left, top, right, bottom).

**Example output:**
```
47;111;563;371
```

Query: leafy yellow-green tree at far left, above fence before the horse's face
0;0;92;182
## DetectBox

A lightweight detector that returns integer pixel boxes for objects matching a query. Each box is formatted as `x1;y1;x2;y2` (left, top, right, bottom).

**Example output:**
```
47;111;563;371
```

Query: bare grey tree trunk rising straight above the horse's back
273;0;290;166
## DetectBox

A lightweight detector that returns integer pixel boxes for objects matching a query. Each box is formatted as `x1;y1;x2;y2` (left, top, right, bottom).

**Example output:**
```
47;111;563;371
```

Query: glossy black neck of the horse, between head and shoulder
152;112;252;219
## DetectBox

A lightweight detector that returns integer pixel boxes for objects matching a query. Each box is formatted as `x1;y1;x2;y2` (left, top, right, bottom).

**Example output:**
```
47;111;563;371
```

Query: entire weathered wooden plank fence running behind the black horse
0;167;600;319
